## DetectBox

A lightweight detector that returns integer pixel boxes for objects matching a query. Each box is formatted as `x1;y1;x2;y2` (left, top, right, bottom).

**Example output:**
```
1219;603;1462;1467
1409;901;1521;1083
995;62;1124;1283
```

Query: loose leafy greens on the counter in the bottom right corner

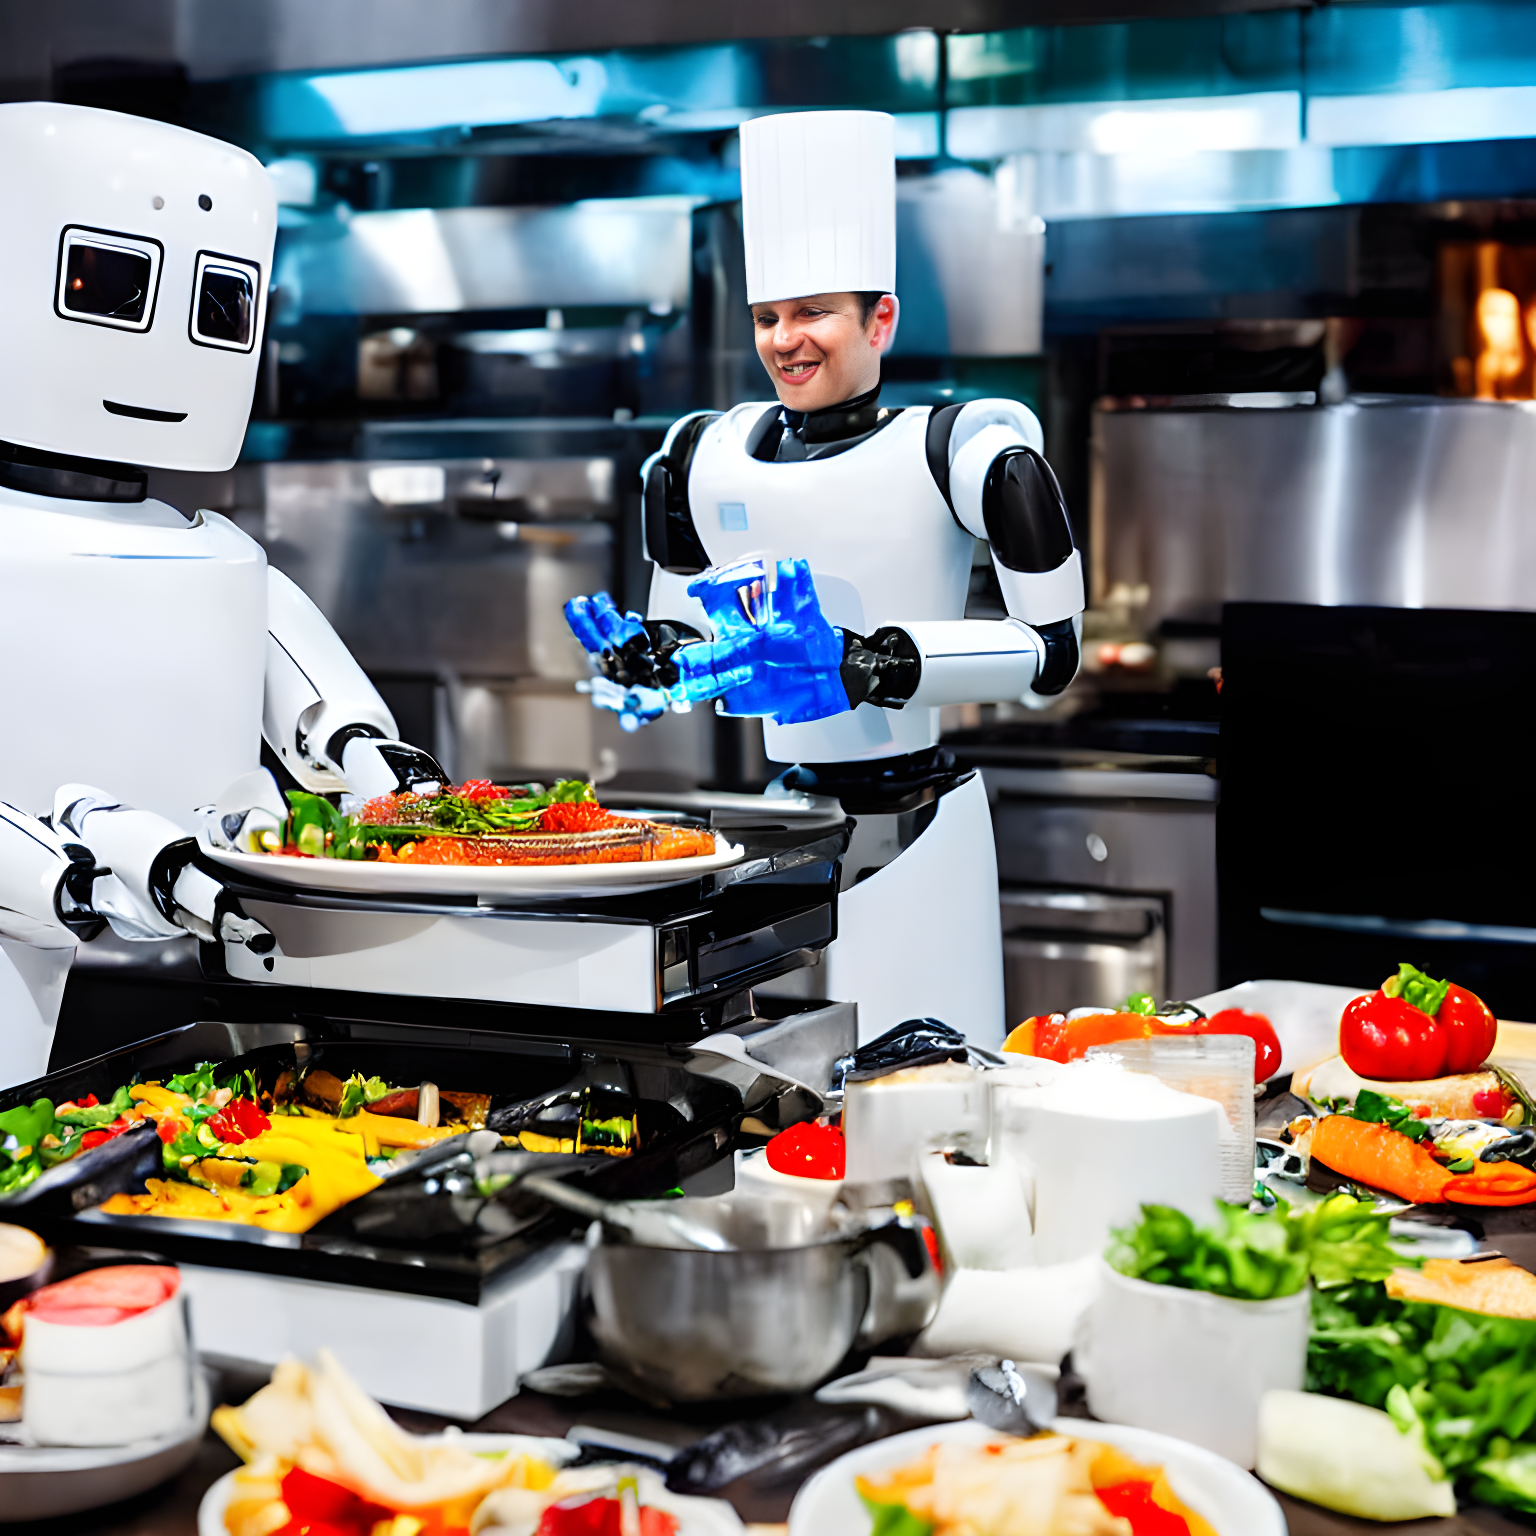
1307;1283;1536;1513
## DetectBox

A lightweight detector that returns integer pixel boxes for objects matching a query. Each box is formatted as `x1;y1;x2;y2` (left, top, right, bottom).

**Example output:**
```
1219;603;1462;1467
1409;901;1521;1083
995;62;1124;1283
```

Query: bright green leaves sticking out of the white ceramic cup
1106;1192;1405;1301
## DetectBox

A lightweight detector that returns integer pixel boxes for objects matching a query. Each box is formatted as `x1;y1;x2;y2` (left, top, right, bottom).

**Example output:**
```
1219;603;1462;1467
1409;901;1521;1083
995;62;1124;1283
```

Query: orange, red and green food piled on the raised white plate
262;779;716;866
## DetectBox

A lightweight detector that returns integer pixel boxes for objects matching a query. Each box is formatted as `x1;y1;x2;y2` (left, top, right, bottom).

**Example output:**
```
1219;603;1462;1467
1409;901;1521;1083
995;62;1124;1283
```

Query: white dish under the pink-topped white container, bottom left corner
0;1373;208;1517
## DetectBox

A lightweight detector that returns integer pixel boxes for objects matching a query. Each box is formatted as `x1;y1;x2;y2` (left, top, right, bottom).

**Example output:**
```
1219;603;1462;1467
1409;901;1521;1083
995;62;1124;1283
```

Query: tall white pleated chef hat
742;112;895;304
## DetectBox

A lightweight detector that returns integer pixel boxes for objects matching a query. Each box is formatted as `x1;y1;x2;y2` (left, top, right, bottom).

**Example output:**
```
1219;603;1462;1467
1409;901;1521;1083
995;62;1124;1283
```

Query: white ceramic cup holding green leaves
1072;1261;1312;1467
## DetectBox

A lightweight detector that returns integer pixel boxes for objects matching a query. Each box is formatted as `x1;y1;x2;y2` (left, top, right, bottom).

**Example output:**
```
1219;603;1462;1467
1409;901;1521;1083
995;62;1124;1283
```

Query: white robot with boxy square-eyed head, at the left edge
0;103;441;1084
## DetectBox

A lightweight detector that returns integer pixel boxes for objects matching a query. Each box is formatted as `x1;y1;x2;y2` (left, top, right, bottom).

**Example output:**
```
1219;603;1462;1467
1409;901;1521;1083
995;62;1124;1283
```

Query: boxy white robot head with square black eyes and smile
0;101;276;470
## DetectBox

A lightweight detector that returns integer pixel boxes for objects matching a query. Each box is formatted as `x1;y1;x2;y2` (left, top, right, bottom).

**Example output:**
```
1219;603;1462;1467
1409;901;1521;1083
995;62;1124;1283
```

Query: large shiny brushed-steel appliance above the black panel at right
1091;396;1536;642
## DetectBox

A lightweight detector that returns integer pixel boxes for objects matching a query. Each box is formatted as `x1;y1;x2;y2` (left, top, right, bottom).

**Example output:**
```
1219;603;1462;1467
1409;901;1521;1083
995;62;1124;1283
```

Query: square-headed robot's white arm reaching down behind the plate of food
261;567;445;799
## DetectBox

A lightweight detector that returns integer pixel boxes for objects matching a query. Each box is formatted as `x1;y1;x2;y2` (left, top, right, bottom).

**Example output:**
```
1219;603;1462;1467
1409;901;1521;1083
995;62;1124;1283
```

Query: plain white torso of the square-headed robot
0;507;266;825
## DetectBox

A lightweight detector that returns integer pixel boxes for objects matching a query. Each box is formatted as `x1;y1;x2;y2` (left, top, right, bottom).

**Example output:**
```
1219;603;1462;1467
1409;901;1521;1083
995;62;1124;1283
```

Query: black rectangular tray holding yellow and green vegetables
0;1020;743;1303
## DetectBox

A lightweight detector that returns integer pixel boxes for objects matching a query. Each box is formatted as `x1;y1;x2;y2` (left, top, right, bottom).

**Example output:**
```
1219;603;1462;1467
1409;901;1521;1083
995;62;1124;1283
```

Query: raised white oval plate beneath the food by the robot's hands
201;833;742;902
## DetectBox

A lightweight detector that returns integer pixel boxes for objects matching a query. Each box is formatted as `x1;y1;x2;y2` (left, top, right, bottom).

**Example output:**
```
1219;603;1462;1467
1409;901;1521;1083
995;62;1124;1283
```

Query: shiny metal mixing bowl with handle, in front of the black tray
587;1195;938;1402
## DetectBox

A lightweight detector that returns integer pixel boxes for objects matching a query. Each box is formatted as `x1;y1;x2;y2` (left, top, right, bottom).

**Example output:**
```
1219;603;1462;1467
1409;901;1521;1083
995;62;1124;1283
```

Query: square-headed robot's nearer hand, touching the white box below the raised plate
54;783;276;954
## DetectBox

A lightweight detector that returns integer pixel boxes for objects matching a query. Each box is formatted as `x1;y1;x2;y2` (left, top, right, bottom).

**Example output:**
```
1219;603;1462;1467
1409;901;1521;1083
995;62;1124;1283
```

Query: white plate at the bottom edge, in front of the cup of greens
792;1419;1286;1536
